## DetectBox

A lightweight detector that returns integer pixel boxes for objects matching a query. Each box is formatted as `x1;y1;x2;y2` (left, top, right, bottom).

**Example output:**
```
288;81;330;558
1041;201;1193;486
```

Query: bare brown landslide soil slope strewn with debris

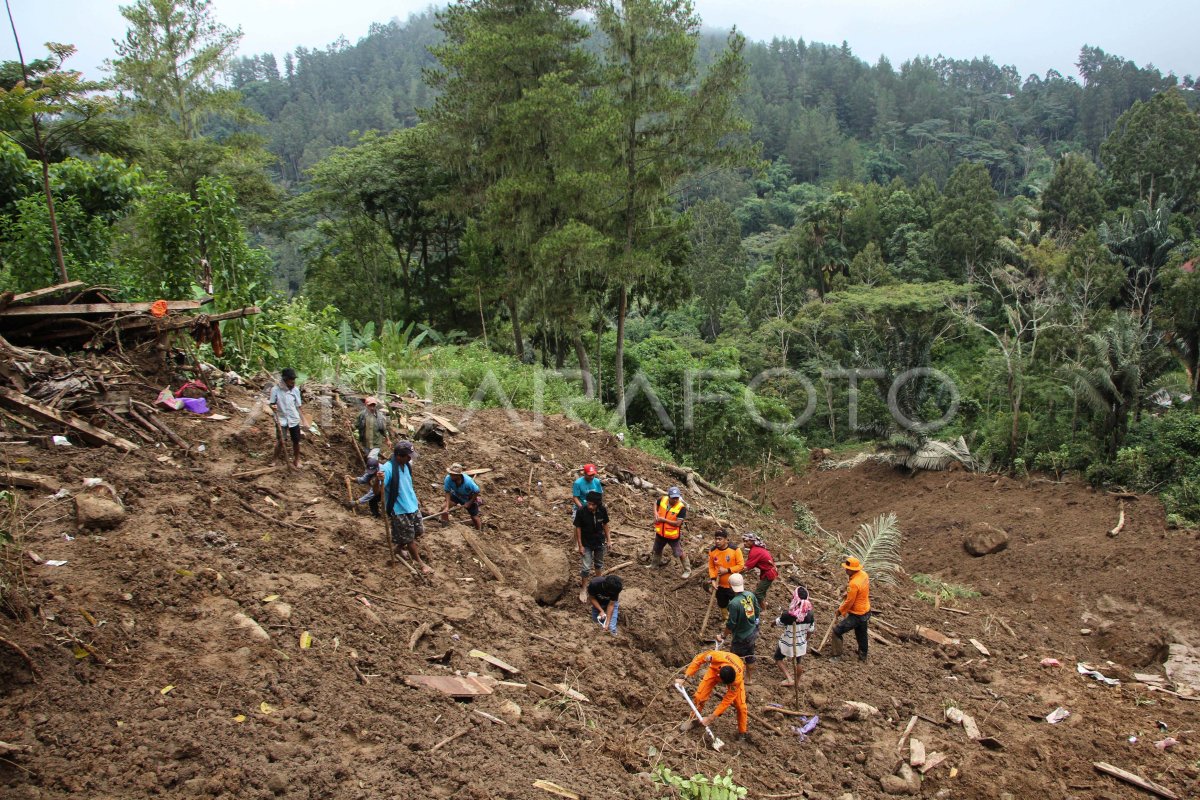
0;387;1200;799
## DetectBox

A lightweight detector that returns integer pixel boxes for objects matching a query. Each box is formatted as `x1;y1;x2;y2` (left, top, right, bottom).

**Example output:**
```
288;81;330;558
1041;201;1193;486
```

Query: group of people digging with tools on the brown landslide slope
269;369;871;738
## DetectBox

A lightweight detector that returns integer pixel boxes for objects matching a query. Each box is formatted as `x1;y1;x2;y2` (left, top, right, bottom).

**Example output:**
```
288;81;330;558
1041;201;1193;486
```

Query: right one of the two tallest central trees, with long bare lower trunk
596;0;751;420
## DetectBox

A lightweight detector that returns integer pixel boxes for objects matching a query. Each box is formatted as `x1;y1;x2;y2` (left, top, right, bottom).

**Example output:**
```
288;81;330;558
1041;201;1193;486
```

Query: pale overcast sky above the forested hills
0;0;1200;77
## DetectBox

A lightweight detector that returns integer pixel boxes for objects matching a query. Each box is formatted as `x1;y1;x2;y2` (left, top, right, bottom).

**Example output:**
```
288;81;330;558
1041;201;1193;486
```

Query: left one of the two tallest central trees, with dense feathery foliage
425;0;610;357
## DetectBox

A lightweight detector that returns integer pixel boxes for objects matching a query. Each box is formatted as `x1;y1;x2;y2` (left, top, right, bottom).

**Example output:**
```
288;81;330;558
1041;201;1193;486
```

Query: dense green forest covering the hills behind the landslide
0;0;1200;524
